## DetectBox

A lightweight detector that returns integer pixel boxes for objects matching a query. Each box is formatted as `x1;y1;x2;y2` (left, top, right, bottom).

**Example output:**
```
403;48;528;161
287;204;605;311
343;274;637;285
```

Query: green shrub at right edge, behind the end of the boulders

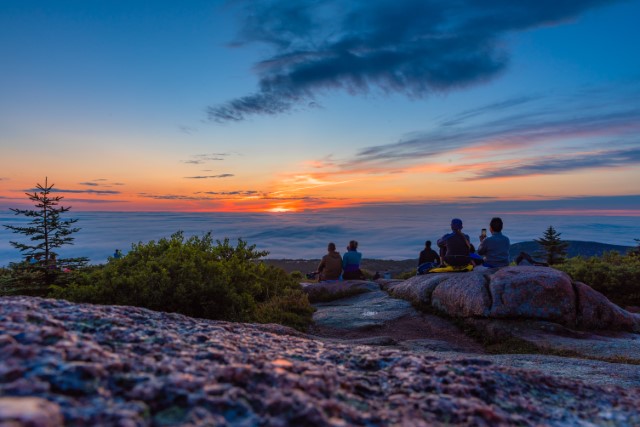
554;252;640;307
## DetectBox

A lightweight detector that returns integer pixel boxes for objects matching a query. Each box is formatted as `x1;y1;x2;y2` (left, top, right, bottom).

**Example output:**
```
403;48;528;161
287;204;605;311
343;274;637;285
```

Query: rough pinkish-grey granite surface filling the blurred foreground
0;297;640;426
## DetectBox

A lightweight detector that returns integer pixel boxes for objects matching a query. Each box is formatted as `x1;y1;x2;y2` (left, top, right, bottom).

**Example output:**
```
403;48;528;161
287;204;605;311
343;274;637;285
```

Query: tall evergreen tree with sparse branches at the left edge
4;178;88;287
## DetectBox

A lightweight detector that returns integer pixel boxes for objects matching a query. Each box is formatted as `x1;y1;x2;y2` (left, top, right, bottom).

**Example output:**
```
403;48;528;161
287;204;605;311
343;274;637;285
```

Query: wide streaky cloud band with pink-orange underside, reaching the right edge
287;82;640;182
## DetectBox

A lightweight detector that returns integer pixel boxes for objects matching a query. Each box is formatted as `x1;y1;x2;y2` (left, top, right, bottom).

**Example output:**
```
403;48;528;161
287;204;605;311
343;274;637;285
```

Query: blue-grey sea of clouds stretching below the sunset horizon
0;205;640;266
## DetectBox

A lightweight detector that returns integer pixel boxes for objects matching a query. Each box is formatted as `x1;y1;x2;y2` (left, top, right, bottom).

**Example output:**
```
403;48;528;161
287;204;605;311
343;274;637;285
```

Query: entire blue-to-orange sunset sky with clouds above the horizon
0;0;640;216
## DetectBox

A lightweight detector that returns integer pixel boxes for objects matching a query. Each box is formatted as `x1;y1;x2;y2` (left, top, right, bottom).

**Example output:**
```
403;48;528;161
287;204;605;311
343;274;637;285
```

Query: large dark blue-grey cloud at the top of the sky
208;0;612;122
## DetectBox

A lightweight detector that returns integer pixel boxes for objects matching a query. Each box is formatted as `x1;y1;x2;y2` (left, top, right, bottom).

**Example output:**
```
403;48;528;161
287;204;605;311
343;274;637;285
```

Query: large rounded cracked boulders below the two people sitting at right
387;267;640;332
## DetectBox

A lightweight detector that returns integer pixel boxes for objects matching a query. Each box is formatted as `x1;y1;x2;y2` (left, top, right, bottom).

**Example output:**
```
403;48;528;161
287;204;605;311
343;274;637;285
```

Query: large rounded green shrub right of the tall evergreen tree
51;232;313;329
